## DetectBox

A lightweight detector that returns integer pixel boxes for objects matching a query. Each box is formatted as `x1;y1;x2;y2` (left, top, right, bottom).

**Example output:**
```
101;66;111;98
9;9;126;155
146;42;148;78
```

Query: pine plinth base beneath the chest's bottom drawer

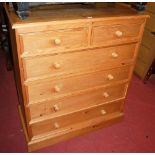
28;113;124;152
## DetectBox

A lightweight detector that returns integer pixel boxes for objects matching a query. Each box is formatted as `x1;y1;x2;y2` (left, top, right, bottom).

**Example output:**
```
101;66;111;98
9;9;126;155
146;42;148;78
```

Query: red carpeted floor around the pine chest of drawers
0;51;155;152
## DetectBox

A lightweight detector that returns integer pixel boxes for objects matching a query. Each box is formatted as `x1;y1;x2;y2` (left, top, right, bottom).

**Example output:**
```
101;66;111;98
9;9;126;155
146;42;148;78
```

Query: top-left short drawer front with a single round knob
21;28;88;55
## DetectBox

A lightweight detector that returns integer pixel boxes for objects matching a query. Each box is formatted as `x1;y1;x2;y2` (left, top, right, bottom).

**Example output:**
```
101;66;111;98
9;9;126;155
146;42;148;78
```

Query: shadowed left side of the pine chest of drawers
9;25;31;140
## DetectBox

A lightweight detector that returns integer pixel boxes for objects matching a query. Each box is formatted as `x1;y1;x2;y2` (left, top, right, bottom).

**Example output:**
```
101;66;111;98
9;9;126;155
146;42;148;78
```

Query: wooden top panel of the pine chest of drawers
5;3;146;28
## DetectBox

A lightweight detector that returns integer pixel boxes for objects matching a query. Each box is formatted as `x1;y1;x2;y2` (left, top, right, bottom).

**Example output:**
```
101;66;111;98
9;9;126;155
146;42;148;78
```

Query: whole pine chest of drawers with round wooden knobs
6;5;147;151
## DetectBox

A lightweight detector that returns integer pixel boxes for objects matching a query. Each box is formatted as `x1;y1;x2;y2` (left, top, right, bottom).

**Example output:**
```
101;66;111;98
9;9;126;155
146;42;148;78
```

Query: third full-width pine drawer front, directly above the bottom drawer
29;84;127;120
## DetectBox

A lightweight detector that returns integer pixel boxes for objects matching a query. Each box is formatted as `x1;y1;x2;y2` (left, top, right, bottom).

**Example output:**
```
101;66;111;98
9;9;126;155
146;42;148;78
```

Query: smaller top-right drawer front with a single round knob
92;23;141;46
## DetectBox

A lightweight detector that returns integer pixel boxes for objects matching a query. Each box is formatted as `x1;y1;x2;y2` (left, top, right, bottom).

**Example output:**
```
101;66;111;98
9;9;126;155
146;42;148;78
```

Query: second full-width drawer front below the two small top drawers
28;66;131;103
